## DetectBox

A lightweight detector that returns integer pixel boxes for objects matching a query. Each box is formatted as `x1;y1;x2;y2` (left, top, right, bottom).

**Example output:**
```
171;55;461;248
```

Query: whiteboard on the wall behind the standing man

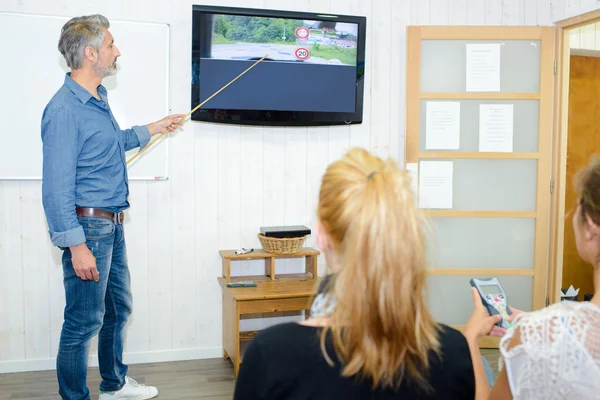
0;13;169;180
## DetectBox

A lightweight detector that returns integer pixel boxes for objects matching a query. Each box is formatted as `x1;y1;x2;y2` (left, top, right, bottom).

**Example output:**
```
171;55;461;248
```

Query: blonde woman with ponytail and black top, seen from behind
234;149;475;400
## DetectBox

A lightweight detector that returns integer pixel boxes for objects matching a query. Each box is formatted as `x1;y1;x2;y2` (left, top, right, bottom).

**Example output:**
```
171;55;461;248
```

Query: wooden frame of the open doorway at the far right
548;10;600;304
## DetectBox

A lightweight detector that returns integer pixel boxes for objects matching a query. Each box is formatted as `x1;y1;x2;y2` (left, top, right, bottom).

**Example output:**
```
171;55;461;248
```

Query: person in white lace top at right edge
465;159;600;400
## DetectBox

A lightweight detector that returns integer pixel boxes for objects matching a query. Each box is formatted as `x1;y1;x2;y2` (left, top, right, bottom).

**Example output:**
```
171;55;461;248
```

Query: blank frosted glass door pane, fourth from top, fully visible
427;217;535;273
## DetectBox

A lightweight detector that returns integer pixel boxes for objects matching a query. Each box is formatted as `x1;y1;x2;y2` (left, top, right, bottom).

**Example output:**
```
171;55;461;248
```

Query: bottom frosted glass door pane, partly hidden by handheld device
427;275;533;325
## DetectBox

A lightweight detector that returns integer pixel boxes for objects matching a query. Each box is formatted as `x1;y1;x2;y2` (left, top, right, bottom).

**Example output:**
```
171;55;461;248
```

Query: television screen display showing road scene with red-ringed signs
192;14;359;113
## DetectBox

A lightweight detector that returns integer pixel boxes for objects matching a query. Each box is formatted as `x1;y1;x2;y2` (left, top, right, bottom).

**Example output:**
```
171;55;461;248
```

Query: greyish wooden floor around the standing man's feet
0;349;499;400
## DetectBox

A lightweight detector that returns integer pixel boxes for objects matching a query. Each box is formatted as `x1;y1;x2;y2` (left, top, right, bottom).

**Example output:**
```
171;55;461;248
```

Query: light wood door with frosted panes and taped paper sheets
405;26;554;346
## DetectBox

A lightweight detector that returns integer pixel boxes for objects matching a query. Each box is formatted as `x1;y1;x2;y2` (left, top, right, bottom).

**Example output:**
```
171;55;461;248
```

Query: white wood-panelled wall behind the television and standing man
0;0;598;372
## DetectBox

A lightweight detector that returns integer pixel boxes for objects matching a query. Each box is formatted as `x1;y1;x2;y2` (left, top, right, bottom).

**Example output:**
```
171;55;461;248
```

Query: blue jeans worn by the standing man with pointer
56;217;131;400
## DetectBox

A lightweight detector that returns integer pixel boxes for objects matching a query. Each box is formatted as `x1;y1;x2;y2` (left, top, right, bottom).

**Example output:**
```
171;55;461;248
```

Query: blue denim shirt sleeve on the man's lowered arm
42;107;86;247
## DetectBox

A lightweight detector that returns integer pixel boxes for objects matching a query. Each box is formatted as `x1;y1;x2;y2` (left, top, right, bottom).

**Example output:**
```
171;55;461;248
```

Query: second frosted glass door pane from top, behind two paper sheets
419;100;539;152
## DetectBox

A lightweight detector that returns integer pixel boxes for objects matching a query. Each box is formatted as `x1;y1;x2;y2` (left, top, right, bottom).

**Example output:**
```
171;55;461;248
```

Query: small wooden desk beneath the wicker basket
218;247;320;378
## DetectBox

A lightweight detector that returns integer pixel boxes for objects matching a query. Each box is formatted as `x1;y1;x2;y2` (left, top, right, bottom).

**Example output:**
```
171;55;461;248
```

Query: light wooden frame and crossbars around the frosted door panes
404;26;555;347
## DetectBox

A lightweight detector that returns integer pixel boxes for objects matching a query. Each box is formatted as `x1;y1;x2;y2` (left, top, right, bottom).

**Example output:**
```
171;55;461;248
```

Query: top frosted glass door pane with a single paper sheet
420;40;540;93
